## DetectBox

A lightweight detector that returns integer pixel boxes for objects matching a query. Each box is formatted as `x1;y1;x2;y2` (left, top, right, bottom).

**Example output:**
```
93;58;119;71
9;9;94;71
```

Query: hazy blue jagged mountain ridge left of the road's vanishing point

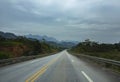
25;34;58;42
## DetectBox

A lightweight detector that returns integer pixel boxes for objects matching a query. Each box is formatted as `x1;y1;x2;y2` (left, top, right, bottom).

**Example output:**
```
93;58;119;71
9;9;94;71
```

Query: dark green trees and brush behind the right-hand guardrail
71;39;120;61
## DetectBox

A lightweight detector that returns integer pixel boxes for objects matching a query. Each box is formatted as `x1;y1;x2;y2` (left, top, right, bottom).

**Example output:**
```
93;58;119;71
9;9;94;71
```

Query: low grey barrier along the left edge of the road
0;53;55;67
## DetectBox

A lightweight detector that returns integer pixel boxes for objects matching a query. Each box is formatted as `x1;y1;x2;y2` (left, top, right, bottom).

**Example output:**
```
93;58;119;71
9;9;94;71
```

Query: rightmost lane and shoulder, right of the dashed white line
66;52;120;82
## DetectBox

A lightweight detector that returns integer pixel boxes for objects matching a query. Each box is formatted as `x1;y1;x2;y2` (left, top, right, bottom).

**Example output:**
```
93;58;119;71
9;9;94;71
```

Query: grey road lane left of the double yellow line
0;54;59;82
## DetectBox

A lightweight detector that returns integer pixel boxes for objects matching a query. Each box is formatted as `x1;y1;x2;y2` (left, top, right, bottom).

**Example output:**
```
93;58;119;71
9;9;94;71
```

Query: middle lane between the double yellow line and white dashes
35;54;83;82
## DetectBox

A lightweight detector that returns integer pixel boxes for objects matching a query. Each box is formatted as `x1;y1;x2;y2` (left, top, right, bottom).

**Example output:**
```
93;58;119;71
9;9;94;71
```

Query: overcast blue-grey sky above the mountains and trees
0;0;120;43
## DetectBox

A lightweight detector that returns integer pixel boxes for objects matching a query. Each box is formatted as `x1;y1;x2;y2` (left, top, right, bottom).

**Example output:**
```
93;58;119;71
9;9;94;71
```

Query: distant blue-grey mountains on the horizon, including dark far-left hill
0;31;79;48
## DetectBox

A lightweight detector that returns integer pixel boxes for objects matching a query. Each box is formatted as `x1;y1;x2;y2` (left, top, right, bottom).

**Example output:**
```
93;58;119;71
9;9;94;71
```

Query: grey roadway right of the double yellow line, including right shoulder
35;51;120;82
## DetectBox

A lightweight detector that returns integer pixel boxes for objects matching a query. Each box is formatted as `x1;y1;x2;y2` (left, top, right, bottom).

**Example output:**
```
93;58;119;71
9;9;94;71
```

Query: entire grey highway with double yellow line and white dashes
0;50;120;82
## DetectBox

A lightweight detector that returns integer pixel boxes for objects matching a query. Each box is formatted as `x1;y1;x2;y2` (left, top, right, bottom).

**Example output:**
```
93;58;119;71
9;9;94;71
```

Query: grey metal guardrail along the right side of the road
76;54;120;66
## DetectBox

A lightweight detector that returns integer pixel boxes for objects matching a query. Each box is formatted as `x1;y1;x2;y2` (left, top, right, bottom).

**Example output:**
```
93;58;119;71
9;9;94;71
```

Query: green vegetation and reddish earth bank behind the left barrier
0;36;59;59
